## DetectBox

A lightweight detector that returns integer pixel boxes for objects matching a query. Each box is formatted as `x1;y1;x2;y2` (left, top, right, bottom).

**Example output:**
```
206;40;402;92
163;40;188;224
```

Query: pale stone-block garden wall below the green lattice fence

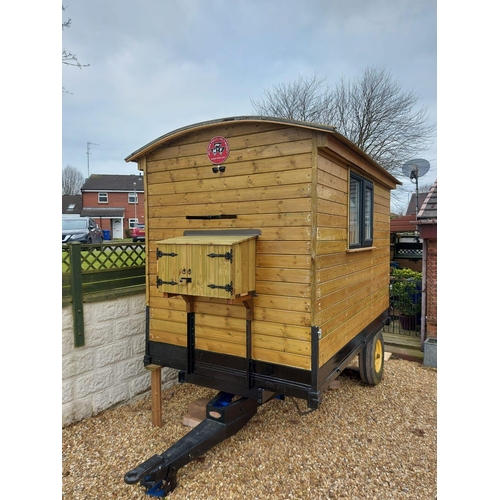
62;294;177;427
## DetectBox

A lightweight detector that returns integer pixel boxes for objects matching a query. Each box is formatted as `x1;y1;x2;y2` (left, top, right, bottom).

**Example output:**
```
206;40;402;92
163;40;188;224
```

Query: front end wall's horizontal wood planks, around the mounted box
146;127;312;369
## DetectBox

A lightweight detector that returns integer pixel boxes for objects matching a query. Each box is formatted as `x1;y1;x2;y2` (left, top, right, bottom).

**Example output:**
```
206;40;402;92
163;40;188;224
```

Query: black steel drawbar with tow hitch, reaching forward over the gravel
124;392;259;497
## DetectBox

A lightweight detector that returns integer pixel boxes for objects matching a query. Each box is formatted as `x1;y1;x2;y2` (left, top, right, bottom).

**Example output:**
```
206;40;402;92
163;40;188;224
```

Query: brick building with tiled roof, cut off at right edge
417;181;437;338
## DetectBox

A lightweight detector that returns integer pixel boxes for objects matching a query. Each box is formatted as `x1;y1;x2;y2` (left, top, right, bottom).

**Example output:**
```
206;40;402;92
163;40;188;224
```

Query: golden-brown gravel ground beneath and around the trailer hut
62;358;437;500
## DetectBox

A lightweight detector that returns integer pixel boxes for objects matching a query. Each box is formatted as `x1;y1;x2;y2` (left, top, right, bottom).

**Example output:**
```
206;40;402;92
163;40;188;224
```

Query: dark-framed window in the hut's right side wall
349;172;373;248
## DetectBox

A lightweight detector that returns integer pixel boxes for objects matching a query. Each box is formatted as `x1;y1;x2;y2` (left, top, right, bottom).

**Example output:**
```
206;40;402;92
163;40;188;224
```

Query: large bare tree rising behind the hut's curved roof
251;67;436;177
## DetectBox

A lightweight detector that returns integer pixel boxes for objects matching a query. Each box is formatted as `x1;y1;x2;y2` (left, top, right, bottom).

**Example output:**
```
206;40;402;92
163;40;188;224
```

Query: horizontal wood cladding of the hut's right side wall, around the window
312;155;390;360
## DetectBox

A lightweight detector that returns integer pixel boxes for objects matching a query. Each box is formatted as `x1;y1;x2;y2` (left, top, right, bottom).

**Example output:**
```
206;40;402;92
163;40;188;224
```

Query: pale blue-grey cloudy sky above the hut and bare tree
62;0;437;211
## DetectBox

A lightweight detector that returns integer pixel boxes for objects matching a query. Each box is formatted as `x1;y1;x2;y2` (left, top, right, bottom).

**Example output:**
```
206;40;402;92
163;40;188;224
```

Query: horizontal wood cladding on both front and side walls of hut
137;122;392;370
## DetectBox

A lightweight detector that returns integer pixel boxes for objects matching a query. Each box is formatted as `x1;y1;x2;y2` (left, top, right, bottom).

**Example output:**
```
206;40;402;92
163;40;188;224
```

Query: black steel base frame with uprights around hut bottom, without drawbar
144;308;389;410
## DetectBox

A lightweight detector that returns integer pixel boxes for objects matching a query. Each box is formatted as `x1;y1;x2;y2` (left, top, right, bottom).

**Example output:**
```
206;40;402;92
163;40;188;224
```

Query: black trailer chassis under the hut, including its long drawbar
124;314;387;497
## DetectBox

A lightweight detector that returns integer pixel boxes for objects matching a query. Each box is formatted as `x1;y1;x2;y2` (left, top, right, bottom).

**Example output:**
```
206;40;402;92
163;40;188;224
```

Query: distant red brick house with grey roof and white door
81;174;144;239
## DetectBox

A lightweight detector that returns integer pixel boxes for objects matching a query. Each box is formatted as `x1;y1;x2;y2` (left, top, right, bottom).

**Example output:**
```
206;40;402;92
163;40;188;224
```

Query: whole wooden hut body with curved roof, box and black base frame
126;117;399;408
